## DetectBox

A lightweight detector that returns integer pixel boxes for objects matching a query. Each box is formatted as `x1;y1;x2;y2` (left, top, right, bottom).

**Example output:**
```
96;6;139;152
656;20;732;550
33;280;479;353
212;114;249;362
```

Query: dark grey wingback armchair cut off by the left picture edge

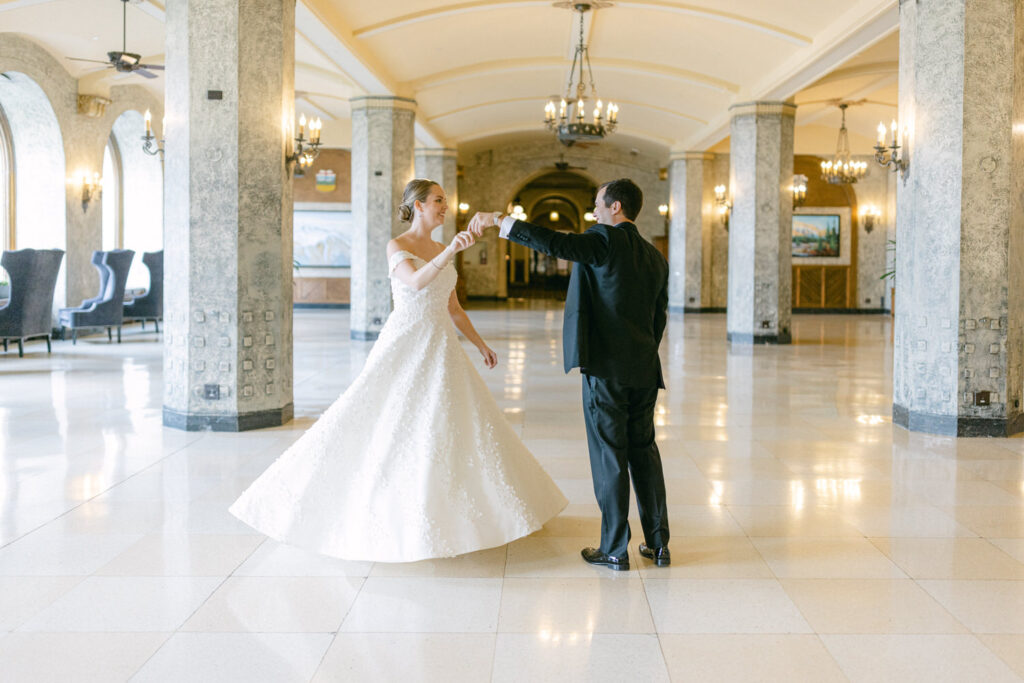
0;249;63;356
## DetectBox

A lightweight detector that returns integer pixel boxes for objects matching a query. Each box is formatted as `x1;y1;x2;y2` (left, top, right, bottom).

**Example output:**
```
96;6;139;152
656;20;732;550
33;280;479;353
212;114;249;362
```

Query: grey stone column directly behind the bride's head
350;96;416;340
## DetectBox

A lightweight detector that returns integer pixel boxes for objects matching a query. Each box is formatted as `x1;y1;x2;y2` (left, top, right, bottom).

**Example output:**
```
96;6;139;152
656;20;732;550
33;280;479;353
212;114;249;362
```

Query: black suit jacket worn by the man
508;220;669;389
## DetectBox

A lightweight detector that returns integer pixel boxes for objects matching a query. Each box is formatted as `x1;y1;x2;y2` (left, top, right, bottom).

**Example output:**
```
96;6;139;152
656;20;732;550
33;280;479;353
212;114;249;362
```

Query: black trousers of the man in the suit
583;375;669;557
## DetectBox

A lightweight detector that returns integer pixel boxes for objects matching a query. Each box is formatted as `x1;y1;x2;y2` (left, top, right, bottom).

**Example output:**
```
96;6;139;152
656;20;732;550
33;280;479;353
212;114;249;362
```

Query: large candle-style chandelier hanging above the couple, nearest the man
544;1;618;146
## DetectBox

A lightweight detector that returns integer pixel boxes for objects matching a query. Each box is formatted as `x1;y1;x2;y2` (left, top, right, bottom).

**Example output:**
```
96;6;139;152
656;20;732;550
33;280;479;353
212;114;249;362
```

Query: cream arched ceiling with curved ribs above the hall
0;0;898;150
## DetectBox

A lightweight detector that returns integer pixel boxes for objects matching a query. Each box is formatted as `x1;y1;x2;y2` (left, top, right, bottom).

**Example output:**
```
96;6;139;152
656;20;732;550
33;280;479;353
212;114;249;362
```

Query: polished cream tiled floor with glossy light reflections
0;302;1024;683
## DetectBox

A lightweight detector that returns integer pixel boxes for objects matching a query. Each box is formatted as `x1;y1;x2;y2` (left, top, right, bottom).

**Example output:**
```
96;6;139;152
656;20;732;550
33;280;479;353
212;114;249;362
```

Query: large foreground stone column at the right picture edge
893;0;1024;436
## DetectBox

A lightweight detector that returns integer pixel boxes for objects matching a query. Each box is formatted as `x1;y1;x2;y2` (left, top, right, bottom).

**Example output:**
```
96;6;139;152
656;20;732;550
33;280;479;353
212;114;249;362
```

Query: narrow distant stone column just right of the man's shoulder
669;152;715;312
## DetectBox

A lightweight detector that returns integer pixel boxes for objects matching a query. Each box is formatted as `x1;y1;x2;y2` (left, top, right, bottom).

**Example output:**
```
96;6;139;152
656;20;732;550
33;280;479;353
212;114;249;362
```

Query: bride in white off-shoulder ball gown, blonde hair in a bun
230;179;567;562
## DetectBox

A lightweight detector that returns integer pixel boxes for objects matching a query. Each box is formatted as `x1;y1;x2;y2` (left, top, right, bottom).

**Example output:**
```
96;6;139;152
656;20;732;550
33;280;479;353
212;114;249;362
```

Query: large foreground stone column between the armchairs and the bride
164;0;295;431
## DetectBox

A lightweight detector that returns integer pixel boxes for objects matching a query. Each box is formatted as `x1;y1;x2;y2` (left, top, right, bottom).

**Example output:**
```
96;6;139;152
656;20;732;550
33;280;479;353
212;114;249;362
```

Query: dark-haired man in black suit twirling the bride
469;178;672;570
